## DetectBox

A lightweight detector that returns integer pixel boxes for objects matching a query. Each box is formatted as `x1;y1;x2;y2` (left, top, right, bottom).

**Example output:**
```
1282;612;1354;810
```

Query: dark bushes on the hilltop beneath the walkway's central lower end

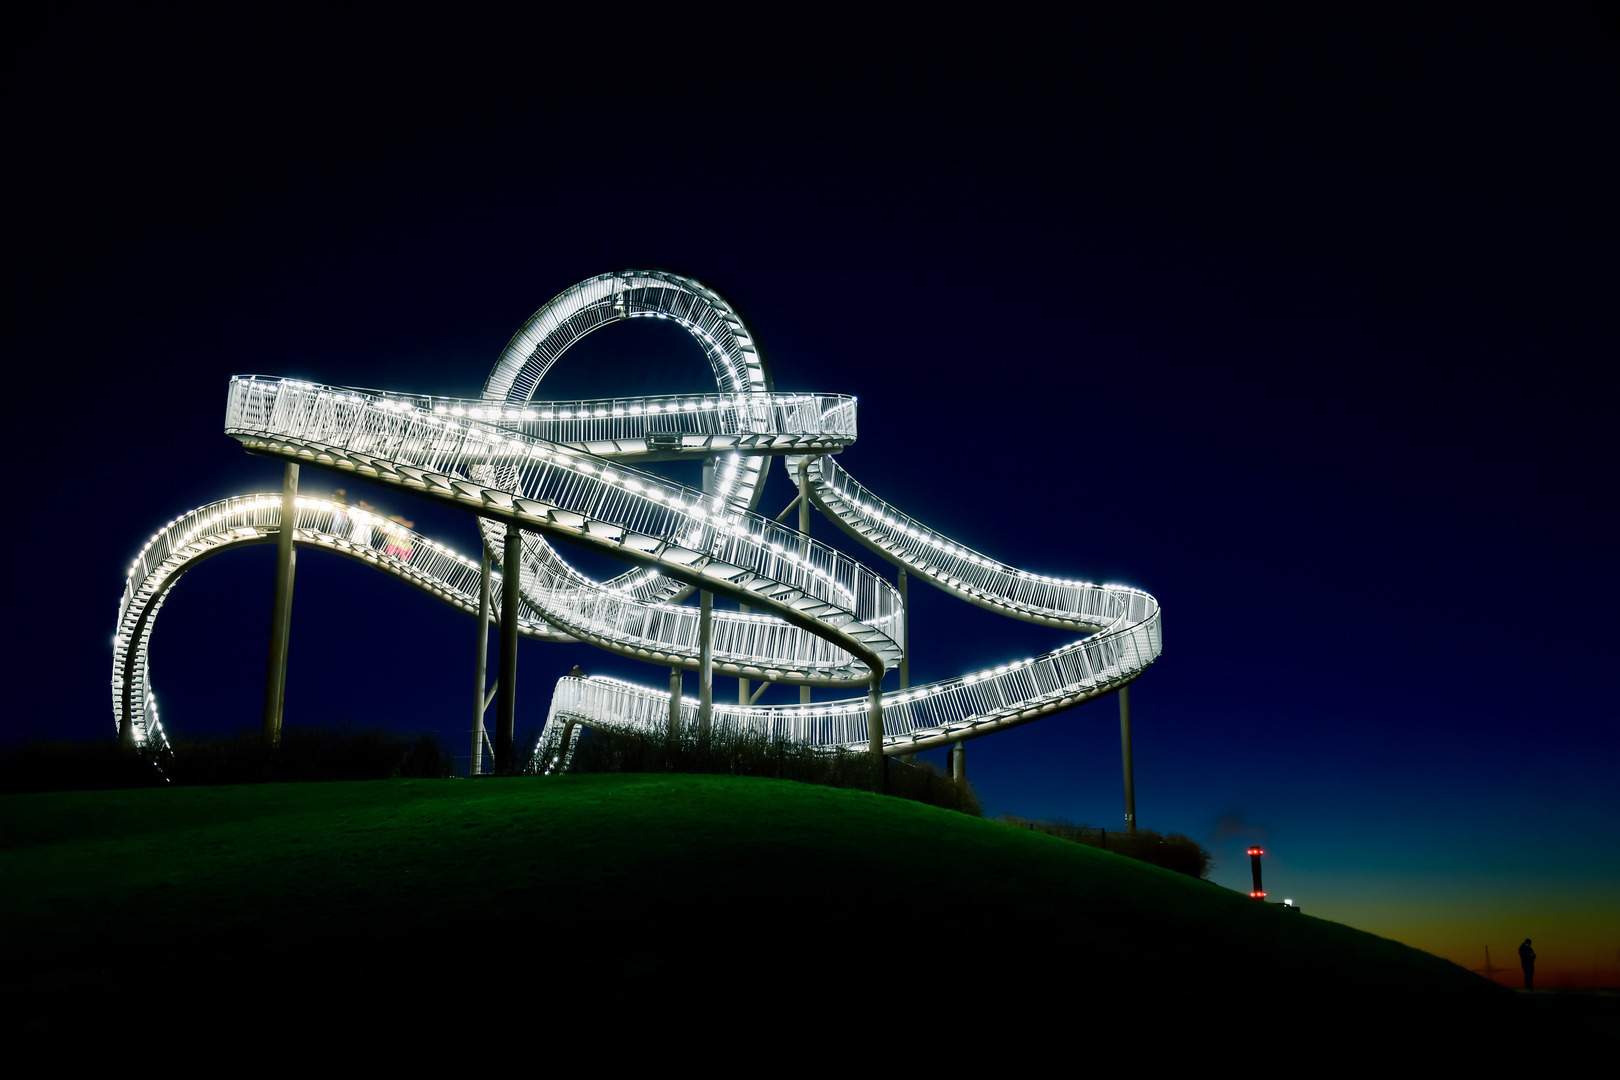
544;724;982;818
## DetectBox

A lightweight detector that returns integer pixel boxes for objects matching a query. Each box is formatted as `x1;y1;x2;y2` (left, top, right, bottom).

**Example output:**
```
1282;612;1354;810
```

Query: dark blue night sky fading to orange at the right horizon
0;6;1620;986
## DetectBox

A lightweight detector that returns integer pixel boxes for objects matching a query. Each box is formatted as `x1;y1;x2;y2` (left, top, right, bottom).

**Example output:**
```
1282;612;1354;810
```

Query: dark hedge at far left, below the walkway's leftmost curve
0;727;454;792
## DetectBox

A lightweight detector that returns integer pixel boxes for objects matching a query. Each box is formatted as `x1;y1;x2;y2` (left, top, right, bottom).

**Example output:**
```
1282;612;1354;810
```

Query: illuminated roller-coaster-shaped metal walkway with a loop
112;270;1162;771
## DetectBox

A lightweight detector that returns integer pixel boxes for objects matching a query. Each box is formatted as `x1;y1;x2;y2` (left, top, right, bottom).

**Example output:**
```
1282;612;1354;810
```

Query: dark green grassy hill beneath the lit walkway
0;774;1568;1040
